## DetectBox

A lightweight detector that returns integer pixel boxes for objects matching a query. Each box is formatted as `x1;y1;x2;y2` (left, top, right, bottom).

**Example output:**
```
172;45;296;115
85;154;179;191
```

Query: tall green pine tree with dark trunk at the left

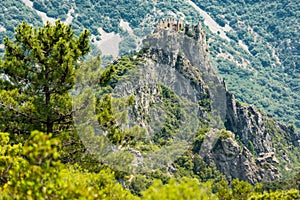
0;20;90;134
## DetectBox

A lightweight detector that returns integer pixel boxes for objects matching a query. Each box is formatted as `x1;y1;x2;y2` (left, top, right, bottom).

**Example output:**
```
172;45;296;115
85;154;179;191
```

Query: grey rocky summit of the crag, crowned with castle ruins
143;19;209;71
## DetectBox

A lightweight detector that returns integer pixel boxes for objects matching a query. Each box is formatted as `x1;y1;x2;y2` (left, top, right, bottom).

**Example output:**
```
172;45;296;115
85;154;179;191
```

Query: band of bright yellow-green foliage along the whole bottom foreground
0;131;300;199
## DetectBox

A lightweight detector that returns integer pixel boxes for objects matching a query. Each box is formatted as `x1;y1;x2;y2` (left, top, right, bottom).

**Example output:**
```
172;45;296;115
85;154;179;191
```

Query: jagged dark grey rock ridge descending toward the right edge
225;93;300;176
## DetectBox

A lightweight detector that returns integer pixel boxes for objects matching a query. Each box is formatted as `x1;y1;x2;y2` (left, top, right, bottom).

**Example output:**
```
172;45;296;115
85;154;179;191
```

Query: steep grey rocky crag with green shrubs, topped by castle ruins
92;20;300;183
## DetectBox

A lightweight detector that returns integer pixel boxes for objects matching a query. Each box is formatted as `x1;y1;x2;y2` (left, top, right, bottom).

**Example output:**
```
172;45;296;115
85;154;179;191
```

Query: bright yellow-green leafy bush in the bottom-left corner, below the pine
0;131;135;199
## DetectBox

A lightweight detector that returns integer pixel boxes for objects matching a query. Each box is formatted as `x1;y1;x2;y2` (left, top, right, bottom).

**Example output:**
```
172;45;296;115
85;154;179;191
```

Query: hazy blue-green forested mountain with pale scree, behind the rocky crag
0;0;300;131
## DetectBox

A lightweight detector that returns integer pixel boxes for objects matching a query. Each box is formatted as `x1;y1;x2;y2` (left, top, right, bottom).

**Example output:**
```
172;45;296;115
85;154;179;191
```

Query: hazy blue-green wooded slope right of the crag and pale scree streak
195;0;300;130
